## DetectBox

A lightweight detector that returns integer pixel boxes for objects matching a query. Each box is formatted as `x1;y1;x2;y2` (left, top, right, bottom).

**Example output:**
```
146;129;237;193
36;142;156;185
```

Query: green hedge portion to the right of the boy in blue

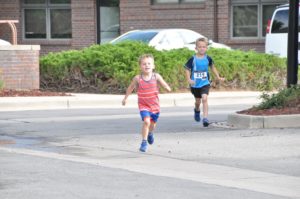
208;49;286;91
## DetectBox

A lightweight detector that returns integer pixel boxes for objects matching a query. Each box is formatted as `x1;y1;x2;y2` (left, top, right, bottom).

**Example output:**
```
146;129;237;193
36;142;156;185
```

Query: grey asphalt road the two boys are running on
0;104;300;199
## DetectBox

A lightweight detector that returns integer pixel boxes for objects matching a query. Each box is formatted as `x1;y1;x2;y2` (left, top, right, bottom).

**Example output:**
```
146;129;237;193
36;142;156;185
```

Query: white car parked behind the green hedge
110;29;231;50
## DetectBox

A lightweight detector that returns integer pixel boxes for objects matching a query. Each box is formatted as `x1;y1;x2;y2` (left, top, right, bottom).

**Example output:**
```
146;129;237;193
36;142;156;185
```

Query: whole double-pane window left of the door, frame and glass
22;0;72;39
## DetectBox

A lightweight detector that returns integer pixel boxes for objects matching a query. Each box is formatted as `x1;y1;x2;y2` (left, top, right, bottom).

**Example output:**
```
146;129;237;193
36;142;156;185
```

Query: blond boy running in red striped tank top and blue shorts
122;54;171;152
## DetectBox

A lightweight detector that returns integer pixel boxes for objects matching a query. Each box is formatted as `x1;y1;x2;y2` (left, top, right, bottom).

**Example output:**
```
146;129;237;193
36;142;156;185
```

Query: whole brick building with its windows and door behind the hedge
0;0;288;54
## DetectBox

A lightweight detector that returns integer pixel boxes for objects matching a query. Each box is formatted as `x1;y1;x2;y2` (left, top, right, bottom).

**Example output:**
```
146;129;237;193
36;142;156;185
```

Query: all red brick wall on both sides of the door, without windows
0;0;264;55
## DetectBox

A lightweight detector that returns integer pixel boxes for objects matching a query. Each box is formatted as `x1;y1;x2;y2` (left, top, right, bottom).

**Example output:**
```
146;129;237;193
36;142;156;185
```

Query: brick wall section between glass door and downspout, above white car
120;0;217;38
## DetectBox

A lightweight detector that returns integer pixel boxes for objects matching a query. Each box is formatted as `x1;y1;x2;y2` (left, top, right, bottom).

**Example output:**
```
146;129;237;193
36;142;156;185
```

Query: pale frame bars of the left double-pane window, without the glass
22;0;73;41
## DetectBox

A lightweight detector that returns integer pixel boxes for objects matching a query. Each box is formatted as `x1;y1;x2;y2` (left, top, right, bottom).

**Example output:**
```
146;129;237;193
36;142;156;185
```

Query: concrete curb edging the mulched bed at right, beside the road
227;113;300;129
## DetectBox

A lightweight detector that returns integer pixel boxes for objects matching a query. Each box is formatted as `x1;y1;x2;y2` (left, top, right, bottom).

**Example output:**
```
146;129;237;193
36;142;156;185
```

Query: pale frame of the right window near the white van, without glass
230;0;285;40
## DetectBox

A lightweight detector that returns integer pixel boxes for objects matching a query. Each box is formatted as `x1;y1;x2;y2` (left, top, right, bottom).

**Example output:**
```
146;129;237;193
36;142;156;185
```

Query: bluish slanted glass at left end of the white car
114;32;157;44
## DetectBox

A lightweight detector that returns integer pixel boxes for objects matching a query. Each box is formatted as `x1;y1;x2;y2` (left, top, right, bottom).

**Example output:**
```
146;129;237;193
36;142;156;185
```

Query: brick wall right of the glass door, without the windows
120;0;264;52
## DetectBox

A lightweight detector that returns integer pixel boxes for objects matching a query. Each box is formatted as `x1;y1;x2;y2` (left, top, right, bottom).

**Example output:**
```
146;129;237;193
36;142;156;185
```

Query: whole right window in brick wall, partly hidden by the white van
231;0;285;38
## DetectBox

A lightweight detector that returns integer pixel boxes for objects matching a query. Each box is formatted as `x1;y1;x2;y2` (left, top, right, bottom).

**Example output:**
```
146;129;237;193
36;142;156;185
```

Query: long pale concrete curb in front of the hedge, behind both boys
0;92;260;112
